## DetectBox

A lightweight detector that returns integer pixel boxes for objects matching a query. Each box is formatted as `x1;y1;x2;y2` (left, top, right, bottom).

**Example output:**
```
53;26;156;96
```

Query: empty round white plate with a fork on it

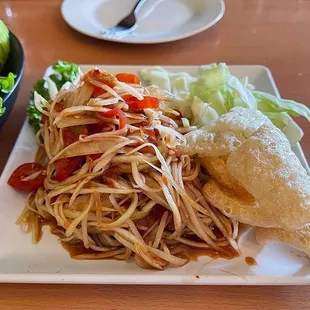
61;0;225;44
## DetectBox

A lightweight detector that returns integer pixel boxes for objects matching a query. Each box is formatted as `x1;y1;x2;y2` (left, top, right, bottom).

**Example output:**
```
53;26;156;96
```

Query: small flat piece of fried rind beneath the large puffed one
255;223;310;256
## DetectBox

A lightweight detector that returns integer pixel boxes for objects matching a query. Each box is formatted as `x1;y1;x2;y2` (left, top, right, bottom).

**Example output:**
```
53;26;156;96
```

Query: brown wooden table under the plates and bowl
0;0;310;310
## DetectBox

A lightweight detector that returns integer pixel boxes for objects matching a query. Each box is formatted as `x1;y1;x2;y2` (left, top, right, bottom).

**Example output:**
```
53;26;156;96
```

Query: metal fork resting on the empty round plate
100;0;146;38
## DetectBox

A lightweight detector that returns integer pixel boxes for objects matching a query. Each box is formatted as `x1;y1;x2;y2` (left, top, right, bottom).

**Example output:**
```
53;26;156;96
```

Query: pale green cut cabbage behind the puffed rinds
140;63;310;146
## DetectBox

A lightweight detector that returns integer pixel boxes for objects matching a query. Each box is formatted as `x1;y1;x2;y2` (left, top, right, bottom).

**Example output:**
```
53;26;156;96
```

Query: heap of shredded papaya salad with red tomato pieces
8;69;239;270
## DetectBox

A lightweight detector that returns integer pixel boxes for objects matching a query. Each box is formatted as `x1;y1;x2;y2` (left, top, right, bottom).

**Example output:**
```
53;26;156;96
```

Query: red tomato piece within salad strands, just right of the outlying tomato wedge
55;156;83;182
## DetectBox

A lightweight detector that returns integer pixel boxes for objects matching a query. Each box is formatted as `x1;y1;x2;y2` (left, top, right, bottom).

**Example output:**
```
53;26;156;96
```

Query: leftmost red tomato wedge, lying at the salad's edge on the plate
8;163;44;192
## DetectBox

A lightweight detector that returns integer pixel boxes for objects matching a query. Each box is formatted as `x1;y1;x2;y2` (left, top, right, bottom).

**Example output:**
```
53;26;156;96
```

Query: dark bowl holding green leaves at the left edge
0;32;25;128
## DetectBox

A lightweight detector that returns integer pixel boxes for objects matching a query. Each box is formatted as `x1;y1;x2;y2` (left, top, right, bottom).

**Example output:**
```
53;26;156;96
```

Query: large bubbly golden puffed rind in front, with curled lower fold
204;124;310;230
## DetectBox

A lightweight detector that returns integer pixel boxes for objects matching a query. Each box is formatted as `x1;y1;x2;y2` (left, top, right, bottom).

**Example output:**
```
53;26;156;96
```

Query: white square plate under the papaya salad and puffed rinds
0;66;310;285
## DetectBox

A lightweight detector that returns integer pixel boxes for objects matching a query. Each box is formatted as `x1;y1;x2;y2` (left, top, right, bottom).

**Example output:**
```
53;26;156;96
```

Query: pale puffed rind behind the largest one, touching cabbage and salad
178;107;271;157
